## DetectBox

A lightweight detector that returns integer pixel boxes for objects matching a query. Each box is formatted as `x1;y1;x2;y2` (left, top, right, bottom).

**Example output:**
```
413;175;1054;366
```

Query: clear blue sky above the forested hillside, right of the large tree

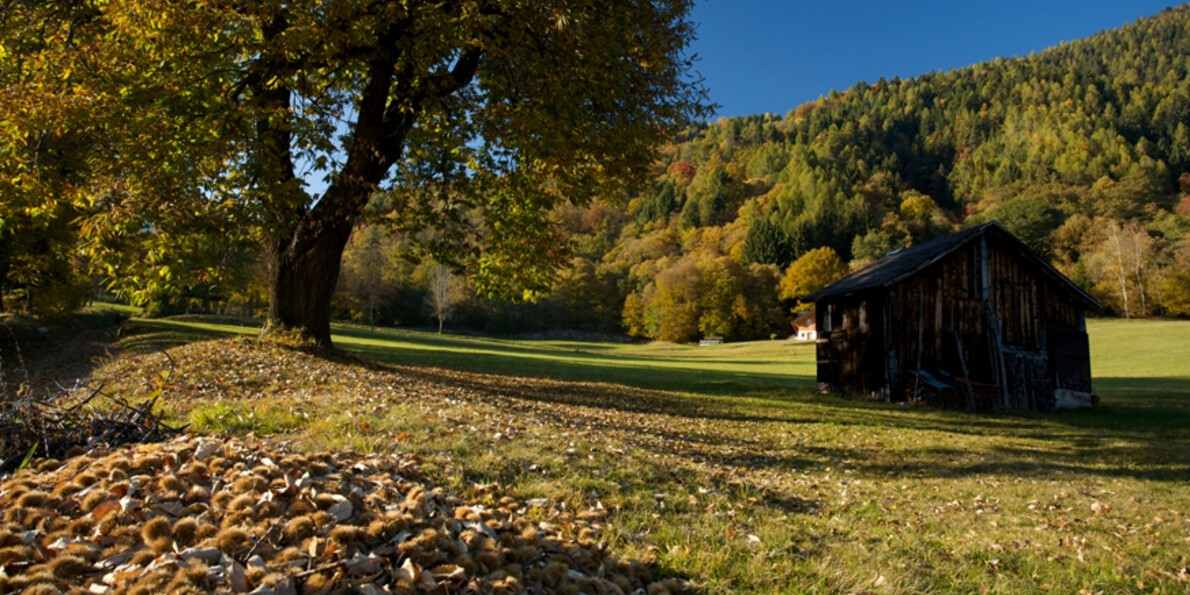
691;0;1176;115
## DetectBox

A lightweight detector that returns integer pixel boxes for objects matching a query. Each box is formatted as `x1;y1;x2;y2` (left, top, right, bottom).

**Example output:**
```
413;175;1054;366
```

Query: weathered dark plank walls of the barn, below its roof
819;224;1089;411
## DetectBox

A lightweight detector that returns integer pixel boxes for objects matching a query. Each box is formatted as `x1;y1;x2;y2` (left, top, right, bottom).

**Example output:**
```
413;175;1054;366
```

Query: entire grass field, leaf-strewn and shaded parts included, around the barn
100;320;1190;593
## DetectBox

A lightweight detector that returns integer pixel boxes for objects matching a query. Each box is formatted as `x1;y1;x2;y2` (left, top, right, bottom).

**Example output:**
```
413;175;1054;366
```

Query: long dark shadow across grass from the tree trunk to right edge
111;316;1190;481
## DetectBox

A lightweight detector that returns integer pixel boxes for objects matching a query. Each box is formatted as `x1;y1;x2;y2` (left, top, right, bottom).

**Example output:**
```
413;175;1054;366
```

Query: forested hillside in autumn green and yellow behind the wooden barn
326;6;1190;340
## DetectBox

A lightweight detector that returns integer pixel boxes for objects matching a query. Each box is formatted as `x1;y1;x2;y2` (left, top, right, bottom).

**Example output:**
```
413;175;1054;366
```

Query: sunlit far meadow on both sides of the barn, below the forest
111;317;1190;408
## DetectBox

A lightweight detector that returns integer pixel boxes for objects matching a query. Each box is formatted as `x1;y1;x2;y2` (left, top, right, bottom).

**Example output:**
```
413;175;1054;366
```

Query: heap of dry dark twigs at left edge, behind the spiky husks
0;386;186;474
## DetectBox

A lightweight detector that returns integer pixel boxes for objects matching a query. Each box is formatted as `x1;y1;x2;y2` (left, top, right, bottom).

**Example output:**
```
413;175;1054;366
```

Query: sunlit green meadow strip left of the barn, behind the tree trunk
111;317;814;395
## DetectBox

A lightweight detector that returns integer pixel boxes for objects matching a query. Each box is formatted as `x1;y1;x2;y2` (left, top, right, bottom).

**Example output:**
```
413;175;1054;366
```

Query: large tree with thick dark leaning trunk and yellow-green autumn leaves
0;0;704;344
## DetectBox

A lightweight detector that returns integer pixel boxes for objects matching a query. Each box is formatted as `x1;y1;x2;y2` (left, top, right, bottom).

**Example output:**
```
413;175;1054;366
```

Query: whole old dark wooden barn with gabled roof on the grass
806;223;1102;412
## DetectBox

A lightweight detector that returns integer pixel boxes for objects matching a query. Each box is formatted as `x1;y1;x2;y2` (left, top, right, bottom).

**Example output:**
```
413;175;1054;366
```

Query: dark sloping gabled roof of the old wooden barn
803;221;1103;309
